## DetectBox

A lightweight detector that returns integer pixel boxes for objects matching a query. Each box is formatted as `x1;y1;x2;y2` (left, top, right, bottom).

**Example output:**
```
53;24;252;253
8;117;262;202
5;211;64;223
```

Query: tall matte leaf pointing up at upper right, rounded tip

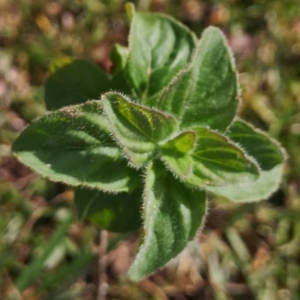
157;27;239;131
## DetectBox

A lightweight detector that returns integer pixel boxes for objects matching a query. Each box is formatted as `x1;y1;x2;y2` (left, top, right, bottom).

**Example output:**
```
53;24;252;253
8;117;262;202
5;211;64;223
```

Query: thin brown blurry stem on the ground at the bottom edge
97;230;108;300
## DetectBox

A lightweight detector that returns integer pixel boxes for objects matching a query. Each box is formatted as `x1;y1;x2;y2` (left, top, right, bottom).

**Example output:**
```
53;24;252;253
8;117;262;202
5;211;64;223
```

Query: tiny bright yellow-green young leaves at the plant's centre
161;131;196;178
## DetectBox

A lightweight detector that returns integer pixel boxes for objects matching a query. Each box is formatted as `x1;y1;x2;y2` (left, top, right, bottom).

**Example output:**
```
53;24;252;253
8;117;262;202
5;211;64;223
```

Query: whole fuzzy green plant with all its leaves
13;5;284;280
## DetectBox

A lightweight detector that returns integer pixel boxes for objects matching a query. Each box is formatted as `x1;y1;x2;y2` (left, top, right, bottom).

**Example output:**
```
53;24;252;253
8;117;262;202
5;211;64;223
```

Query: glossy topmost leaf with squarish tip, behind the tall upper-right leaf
126;13;195;106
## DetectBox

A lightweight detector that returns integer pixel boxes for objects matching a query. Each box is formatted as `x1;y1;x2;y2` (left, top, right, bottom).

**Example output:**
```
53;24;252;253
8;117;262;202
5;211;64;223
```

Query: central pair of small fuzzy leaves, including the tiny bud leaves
102;93;259;187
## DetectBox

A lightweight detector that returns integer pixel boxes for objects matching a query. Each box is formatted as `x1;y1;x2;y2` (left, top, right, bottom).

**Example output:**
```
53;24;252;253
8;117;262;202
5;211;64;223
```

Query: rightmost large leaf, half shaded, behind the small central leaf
207;120;285;202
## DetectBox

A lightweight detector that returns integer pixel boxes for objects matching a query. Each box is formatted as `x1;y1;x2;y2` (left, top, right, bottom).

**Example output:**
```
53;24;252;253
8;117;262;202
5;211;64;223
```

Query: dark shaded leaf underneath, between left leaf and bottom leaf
75;189;142;232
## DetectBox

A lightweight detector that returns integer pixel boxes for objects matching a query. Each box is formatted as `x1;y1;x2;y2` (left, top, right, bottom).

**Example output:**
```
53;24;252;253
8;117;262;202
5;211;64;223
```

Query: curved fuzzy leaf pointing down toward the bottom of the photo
129;161;206;280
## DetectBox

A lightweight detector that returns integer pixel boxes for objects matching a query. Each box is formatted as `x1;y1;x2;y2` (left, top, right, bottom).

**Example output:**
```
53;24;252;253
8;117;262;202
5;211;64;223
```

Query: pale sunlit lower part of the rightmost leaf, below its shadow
206;164;283;202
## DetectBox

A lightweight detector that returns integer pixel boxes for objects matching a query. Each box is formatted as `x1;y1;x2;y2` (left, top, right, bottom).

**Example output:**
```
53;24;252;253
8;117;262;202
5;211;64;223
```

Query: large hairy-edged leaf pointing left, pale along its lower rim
13;101;136;192
